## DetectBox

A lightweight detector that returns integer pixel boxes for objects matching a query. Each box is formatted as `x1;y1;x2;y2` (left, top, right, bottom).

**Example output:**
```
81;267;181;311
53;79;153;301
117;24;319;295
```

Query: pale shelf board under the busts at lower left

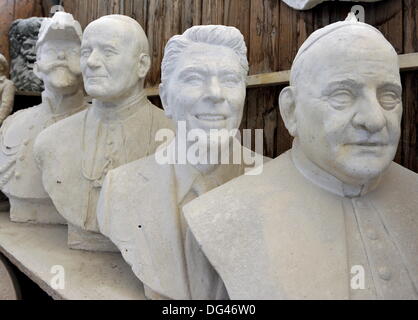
0;212;145;300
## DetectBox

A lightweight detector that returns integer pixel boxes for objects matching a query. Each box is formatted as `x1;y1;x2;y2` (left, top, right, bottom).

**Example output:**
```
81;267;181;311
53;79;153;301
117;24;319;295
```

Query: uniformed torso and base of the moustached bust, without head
0;91;87;223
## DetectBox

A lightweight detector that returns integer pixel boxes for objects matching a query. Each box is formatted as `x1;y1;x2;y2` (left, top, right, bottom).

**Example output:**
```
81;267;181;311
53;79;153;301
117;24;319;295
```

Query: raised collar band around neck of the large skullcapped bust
291;138;380;198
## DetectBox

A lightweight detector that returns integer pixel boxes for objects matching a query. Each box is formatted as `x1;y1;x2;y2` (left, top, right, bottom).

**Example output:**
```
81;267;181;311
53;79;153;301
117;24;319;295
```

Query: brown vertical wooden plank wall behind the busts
0;0;418;172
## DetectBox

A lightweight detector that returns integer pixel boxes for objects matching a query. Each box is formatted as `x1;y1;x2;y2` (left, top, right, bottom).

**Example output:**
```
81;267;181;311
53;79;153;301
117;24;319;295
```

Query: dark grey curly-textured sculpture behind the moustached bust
9;17;44;92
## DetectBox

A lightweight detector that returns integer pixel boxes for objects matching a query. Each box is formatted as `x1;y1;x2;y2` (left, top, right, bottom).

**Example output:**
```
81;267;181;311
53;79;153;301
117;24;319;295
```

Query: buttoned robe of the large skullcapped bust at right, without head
183;142;418;299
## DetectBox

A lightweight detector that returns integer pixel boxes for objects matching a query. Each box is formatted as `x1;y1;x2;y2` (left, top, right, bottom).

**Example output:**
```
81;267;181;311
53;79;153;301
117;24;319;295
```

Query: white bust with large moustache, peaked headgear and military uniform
0;12;86;223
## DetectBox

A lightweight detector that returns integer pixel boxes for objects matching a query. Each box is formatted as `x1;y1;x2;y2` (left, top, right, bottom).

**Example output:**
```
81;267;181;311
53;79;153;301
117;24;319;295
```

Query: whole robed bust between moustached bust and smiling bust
34;15;173;251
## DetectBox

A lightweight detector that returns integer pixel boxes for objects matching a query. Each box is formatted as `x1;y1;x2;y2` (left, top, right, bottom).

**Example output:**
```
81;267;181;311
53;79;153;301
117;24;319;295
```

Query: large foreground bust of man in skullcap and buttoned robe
183;14;418;299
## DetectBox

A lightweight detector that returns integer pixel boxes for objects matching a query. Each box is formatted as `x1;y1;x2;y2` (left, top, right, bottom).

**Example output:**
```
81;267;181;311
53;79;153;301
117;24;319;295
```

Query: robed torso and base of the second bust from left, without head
34;93;173;251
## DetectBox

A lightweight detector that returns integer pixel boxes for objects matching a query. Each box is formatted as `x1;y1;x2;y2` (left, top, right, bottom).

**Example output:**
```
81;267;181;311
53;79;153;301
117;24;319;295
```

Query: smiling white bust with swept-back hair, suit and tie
97;25;263;299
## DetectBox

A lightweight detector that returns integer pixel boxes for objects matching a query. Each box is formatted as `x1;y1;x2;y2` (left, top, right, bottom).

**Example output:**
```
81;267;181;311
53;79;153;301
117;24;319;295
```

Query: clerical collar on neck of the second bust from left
93;90;147;122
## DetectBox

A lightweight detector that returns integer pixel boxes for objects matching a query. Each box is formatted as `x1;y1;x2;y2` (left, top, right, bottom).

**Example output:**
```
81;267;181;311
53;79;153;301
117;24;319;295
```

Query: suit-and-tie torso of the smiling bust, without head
98;141;267;299
